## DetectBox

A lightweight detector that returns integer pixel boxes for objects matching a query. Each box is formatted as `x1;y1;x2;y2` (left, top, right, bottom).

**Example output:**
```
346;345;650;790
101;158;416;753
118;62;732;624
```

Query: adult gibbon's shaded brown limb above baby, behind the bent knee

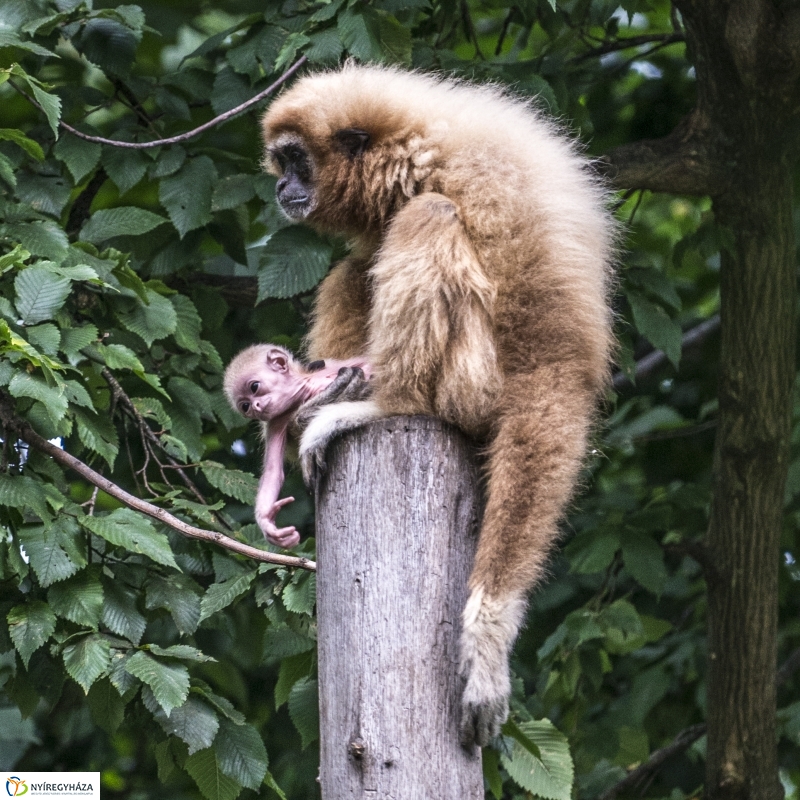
306;258;369;361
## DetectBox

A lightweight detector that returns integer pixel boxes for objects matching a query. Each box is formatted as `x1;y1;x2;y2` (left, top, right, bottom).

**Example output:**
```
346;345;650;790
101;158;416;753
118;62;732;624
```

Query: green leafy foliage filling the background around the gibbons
0;0;800;800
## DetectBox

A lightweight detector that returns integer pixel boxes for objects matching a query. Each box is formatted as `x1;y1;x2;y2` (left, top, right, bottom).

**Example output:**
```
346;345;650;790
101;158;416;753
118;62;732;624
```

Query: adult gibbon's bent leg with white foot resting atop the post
300;193;500;482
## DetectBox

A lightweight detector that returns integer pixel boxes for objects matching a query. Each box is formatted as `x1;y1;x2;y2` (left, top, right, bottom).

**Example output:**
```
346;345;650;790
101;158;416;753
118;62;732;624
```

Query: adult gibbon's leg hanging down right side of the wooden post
461;362;595;745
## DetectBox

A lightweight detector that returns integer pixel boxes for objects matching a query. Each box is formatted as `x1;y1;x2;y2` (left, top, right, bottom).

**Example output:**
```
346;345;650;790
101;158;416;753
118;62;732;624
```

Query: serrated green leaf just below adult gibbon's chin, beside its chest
258;227;333;303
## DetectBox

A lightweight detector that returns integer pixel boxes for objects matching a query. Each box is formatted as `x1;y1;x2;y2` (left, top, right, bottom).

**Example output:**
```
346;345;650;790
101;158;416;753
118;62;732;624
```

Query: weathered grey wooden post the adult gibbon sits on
317;417;484;800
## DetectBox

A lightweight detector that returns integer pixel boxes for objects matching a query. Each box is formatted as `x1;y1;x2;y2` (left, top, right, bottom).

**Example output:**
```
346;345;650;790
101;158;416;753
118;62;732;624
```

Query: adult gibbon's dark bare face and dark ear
268;128;369;222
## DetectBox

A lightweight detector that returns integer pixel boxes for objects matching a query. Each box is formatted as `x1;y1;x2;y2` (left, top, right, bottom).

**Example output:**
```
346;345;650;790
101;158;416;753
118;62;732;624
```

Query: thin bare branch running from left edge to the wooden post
0;393;317;572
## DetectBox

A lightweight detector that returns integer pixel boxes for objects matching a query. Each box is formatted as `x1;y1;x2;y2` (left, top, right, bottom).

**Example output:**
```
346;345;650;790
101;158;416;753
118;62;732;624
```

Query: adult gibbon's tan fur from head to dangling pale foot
263;64;614;744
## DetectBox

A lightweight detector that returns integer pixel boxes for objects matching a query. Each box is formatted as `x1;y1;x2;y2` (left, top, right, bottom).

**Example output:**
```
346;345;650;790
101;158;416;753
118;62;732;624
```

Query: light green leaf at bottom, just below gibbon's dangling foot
500;719;575;800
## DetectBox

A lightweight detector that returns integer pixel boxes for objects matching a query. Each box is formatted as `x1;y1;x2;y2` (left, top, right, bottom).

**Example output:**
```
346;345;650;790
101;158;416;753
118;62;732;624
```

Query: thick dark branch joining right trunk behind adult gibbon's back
599;110;724;195
